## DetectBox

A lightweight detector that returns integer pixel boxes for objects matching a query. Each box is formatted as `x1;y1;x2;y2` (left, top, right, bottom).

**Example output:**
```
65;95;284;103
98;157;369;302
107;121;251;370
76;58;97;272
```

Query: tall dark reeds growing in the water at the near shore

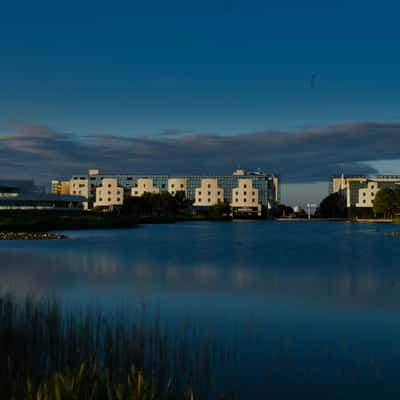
0;295;232;400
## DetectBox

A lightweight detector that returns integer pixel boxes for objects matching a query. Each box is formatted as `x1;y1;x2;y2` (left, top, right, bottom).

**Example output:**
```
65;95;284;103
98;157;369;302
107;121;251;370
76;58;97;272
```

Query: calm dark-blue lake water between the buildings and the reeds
0;221;400;398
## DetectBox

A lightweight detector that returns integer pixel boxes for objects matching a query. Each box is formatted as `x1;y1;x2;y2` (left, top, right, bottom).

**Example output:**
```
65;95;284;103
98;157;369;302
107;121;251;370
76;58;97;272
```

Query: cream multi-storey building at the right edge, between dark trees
331;175;400;208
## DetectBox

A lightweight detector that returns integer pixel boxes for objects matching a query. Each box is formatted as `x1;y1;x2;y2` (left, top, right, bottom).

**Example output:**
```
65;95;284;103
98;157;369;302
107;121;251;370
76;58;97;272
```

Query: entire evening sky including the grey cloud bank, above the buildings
0;0;400;204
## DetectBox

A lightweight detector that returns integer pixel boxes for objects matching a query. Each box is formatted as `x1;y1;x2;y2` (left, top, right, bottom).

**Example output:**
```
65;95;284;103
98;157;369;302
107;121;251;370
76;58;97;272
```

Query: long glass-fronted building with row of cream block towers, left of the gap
59;170;279;213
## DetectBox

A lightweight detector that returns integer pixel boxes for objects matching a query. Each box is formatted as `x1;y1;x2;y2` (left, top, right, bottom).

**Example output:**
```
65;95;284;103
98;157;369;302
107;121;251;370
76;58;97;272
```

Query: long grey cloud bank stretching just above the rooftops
0;122;400;183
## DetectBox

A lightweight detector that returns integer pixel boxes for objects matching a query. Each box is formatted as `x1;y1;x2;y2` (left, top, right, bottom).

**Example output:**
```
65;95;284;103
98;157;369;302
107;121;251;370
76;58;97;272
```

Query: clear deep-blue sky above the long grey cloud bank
0;0;400;205
